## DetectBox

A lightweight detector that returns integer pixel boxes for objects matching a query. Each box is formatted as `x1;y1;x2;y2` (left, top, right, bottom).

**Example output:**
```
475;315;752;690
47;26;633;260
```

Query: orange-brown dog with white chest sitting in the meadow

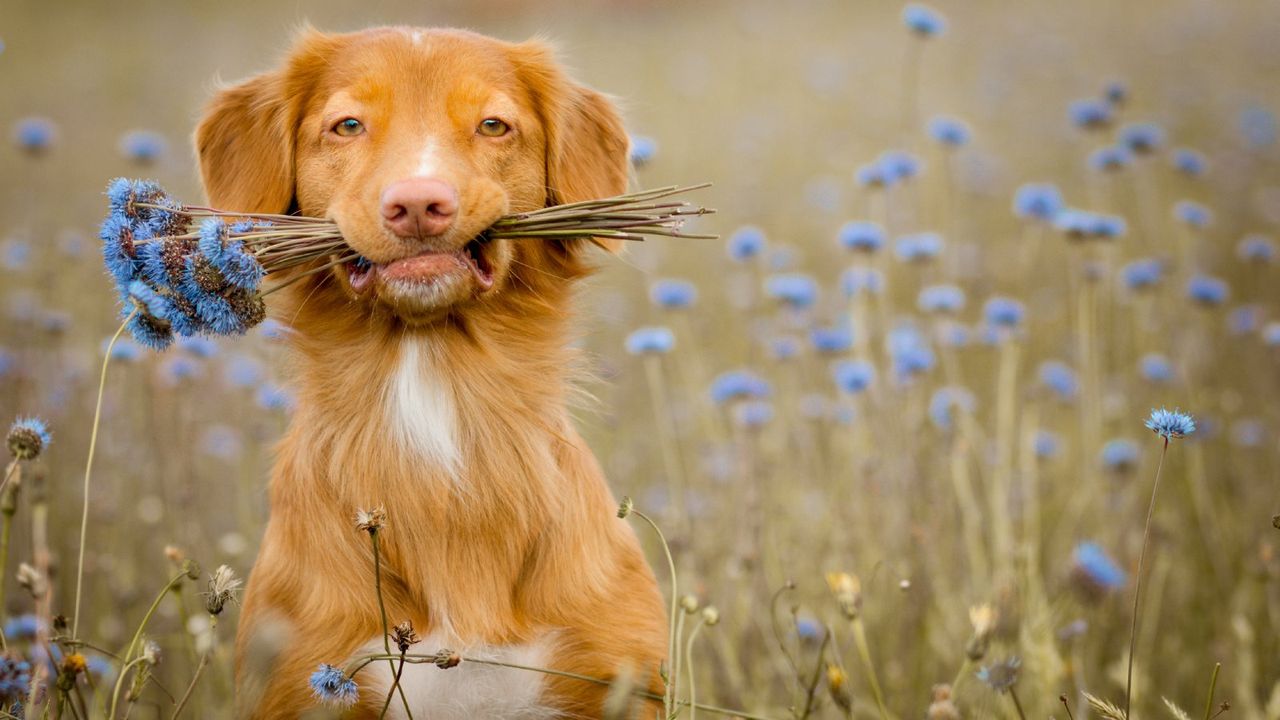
196;27;668;720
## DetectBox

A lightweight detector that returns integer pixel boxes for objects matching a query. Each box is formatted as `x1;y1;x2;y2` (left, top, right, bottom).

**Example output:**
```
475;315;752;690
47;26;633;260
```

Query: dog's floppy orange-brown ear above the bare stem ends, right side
512;41;630;251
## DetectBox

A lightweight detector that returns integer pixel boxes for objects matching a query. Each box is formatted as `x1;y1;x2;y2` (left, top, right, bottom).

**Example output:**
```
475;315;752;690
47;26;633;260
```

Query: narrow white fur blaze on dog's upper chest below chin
385;338;462;477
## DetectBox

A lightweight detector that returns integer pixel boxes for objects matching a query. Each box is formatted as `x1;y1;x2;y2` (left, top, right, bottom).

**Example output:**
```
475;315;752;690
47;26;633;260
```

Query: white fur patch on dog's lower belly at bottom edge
356;632;557;720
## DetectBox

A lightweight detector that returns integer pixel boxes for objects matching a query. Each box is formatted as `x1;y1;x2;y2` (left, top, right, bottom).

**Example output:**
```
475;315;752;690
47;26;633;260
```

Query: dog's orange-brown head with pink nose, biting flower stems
196;28;627;325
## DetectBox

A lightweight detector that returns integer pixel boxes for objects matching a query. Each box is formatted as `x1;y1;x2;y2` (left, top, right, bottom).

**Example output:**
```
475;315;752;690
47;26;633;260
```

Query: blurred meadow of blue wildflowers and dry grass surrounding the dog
0;0;1280;720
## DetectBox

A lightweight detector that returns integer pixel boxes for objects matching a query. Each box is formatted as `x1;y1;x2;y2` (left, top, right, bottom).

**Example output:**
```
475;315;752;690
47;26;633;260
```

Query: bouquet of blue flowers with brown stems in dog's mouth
100;178;716;350
